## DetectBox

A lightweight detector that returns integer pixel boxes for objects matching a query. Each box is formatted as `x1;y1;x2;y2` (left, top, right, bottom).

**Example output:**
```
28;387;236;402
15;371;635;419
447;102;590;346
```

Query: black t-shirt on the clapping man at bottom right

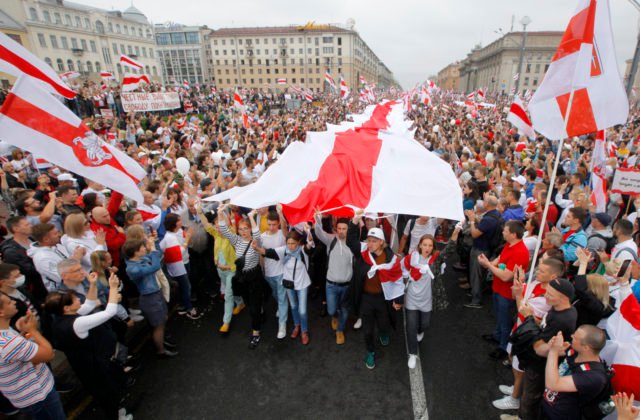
543;355;607;420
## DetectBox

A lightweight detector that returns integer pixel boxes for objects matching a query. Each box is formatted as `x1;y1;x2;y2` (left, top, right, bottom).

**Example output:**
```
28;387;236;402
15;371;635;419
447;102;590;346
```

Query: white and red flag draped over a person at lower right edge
601;293;640;399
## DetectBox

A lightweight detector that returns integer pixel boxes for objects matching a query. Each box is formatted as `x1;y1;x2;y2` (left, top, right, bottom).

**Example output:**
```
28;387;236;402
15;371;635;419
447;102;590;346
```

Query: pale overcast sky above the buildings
76;0;640;87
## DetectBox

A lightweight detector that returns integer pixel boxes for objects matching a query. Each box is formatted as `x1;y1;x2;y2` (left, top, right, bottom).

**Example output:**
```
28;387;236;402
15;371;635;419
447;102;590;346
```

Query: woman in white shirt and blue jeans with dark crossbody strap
252;230;314;345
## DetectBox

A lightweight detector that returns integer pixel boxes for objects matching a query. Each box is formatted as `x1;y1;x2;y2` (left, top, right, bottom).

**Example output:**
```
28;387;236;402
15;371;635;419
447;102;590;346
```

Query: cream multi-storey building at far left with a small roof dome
2;0;161;80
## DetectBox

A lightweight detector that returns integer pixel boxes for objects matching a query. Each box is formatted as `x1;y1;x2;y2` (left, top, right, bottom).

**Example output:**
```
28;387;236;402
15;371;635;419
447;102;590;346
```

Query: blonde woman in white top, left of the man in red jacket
60;213;107;271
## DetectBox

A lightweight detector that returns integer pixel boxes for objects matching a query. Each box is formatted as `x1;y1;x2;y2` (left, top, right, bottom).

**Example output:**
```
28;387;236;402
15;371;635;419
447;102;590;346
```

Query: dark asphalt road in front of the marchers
72;260;512;420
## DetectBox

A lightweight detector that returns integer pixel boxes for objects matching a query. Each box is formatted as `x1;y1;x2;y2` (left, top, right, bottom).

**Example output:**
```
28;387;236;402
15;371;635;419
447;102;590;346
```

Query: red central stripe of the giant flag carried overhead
283;102;394;224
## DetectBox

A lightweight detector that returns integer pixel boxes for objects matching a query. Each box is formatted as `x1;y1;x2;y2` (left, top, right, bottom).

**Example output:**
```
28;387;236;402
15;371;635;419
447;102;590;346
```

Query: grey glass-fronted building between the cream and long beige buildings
155;23;212;84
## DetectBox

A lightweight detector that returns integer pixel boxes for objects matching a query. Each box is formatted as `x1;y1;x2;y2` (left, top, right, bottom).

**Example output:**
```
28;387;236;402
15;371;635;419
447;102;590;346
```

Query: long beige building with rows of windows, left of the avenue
206;23;393;92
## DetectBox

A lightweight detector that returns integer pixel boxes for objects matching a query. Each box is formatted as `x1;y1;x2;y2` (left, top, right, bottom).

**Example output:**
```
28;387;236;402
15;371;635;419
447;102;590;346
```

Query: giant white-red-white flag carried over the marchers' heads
205;101;464;225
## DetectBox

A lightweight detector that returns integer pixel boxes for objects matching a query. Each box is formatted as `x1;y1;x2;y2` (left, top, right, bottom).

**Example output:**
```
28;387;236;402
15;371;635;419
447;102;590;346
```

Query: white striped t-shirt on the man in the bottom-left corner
0;328;54;408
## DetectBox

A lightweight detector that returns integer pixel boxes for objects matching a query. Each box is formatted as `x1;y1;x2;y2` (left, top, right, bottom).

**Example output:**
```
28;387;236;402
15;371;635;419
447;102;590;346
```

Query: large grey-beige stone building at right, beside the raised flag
460;31;563;93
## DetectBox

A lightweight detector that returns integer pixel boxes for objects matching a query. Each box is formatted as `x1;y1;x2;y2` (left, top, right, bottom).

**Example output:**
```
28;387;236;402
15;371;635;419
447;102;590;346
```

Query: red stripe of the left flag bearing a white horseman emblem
0;93;140;184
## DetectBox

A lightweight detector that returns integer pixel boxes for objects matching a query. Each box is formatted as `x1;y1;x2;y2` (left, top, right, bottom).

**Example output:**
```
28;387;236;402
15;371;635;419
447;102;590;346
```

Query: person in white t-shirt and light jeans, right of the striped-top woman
260;205;289;340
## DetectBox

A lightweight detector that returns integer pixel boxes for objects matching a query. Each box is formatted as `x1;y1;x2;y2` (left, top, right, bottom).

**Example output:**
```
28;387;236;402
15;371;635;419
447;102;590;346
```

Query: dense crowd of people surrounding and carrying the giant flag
0;77;640;419
